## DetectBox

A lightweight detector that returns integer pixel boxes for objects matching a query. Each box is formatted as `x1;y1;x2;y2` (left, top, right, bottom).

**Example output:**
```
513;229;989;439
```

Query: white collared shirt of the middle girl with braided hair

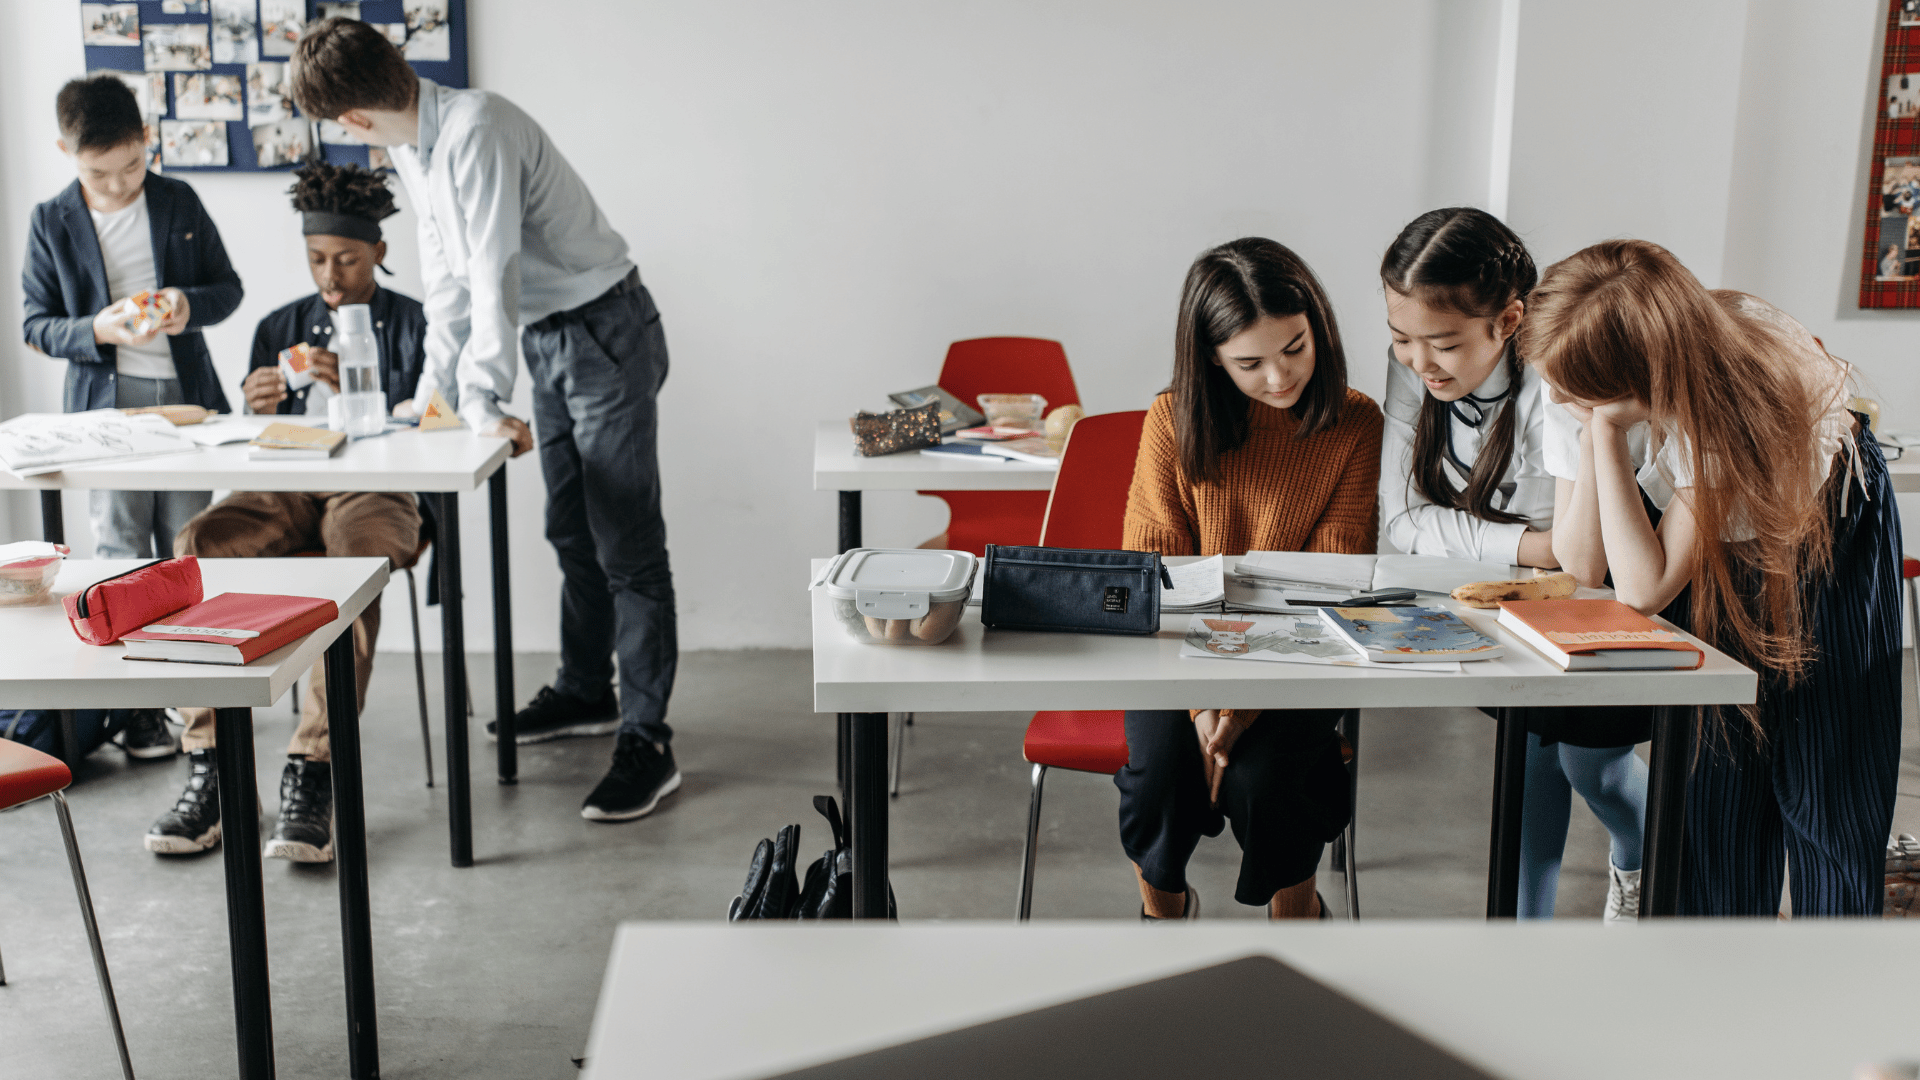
1380;348;1555;565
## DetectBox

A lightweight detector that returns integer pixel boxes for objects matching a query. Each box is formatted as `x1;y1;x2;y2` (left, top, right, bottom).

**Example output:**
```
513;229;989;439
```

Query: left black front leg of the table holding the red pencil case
213;698;276;1080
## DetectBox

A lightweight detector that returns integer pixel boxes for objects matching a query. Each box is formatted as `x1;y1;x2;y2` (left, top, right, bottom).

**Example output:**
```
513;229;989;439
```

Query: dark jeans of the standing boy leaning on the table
520;271;680;742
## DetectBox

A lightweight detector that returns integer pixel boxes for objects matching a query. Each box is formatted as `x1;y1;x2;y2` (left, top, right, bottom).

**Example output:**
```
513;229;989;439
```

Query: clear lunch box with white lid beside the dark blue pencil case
814;548;979;646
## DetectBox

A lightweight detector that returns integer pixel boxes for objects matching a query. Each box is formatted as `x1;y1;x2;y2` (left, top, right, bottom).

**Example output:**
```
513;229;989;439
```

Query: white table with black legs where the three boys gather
0;415;518;867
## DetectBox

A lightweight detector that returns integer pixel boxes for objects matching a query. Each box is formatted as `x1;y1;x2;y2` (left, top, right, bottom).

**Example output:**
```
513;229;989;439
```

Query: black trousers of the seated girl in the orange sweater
1114;709;1354;907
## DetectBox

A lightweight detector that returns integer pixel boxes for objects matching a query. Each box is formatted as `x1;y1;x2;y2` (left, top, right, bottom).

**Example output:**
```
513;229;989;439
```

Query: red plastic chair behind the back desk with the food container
920;338;1082;555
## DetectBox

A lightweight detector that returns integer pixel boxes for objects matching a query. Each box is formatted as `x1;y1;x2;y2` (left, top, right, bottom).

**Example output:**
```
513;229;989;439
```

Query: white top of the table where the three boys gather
0;415;511;492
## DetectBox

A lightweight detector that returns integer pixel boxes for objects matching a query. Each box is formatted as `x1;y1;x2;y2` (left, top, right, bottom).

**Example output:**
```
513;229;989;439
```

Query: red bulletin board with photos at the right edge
1860;0;1920;307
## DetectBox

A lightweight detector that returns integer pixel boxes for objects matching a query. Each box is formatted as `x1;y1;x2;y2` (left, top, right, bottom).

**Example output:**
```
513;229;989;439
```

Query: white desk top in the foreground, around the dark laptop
582;914;1920;1080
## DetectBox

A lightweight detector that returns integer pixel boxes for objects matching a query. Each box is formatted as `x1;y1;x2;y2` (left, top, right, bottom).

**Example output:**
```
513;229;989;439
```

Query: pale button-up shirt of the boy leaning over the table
392;79;634;429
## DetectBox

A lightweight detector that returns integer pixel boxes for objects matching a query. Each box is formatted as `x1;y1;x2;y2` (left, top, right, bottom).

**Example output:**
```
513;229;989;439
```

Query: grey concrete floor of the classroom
0;651;1920;1080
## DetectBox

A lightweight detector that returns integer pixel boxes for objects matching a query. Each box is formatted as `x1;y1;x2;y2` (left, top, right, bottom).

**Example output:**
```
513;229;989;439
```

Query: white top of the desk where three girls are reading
812;559;1757;713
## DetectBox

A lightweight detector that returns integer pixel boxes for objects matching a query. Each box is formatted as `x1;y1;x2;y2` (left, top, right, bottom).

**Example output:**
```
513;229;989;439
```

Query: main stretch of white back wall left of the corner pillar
0;0;1438;650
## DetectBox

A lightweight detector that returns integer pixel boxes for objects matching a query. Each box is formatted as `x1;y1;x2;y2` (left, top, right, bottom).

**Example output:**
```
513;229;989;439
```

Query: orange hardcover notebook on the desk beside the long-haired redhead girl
1500;600;1707;671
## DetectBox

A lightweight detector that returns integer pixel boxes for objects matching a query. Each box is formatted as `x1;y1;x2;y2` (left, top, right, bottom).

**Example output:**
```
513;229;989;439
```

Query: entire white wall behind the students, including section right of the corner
0;0;1920;650
